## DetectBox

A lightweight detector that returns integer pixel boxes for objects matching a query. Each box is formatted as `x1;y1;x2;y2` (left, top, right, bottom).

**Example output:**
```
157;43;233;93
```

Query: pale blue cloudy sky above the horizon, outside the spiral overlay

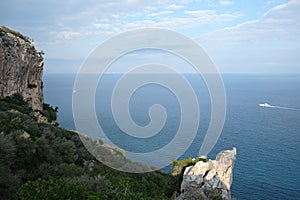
0;0;300;73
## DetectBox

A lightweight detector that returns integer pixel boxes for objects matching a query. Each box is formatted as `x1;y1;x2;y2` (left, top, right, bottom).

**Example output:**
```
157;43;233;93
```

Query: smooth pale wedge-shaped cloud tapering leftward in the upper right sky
199;0;300;42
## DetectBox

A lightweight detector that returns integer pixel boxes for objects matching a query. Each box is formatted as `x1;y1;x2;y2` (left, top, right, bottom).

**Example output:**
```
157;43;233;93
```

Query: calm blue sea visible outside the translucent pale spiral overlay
44;74;300;200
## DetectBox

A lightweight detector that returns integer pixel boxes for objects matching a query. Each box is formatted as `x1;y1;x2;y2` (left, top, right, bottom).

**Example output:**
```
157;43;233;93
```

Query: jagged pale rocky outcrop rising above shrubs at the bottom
176;148;236;200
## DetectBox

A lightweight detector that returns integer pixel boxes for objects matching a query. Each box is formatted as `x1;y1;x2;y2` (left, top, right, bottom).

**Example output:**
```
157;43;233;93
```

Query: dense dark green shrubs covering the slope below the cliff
0;95;179;200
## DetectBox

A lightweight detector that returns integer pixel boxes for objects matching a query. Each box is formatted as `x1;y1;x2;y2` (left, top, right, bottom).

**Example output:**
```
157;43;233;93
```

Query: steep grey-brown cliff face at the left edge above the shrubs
0;27;44;110
